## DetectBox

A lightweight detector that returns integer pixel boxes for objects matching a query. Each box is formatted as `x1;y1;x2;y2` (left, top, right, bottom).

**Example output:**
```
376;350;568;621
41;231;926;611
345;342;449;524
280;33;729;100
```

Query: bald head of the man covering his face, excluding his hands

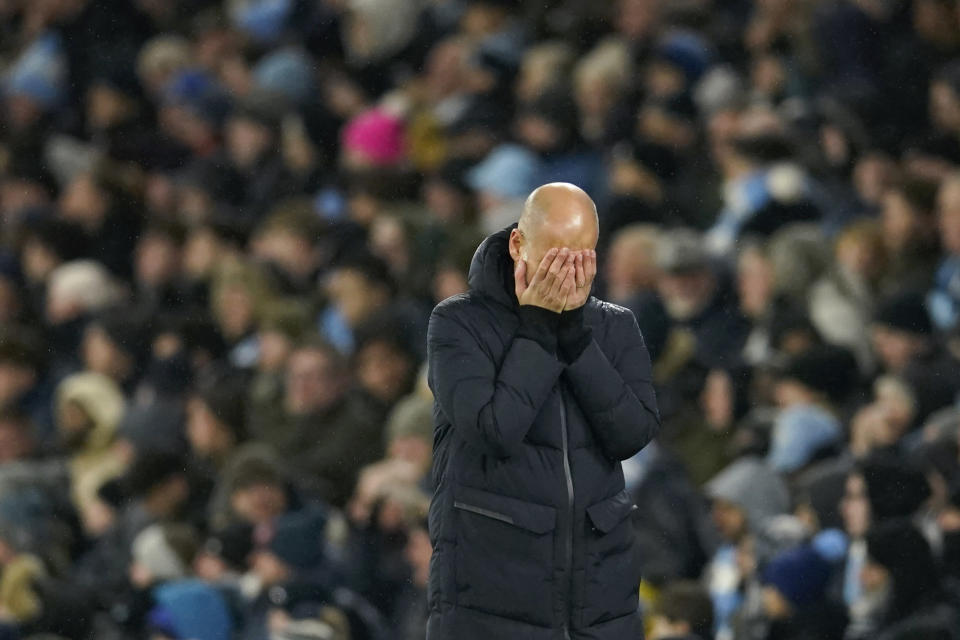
510;182;600;284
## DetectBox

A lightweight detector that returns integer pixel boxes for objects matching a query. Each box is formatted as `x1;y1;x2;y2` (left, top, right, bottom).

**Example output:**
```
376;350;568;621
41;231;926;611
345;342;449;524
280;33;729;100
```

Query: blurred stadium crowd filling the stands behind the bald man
0;0;960;640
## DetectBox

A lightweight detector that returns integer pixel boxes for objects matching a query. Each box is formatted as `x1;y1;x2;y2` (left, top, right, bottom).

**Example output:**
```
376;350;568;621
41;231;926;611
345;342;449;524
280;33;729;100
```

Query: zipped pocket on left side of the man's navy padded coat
453;486;557;625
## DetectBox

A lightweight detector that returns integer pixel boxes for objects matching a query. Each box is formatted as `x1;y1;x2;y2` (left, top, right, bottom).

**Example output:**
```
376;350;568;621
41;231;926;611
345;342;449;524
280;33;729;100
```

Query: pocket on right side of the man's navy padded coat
582;489;640;626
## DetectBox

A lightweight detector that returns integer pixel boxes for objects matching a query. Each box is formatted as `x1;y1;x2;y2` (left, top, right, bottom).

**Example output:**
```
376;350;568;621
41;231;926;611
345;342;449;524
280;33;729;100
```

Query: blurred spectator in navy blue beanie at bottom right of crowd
761;546;847;640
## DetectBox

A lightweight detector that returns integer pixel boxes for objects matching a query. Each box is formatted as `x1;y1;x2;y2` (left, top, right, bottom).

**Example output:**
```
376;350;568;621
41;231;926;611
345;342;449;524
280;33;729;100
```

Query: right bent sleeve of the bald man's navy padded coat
566;311;660;460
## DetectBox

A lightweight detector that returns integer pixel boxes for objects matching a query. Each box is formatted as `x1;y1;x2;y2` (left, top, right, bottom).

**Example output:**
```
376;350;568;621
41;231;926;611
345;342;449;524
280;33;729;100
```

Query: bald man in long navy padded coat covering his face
427;184;660;640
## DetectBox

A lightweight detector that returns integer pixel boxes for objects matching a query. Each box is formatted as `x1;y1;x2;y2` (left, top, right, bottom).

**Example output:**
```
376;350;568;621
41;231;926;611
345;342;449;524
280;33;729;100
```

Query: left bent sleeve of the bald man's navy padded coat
427;308;563;458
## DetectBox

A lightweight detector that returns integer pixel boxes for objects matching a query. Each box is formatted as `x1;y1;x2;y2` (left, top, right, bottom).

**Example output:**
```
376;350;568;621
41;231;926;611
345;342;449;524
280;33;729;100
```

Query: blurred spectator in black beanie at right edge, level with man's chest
871;291;960;421
